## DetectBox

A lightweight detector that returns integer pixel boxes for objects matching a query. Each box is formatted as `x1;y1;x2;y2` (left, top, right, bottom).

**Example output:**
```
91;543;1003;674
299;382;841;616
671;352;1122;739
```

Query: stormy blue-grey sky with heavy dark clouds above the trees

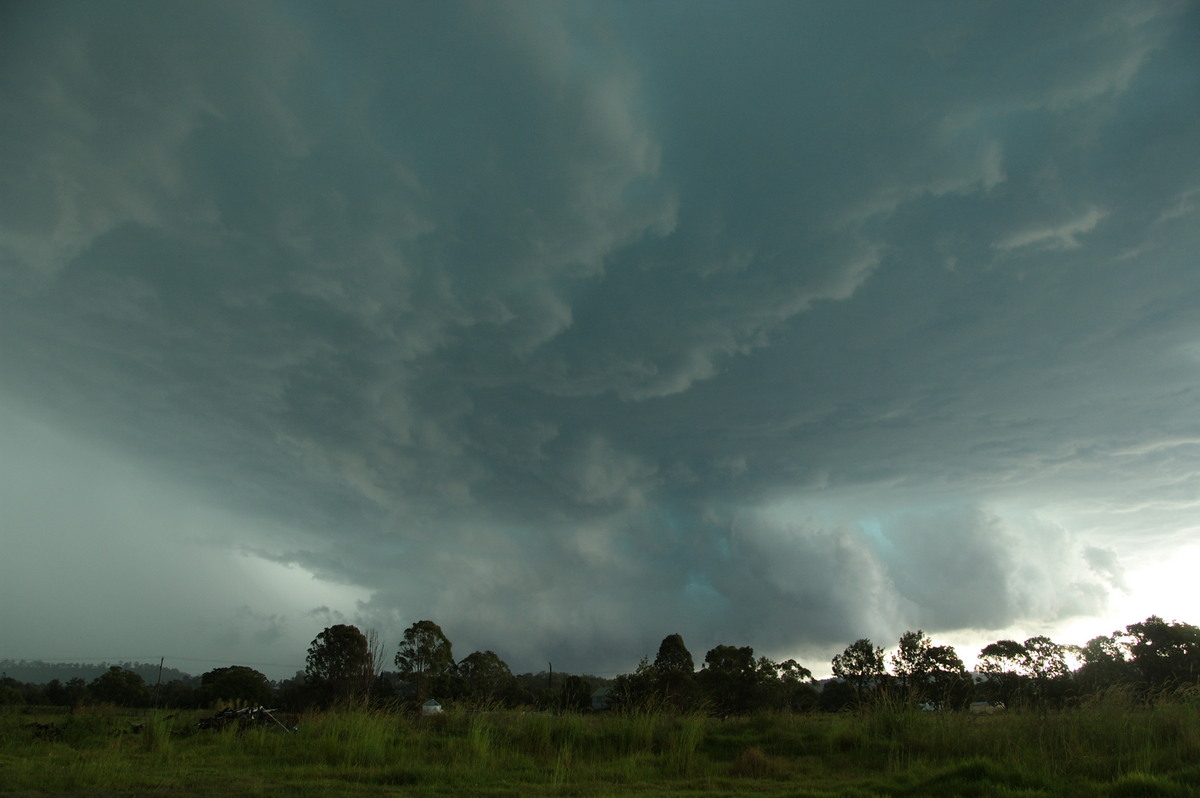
0;0;1200;678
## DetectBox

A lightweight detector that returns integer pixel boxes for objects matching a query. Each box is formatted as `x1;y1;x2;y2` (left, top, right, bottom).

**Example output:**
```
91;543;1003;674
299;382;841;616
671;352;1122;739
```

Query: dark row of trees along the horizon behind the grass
0;616;1200;715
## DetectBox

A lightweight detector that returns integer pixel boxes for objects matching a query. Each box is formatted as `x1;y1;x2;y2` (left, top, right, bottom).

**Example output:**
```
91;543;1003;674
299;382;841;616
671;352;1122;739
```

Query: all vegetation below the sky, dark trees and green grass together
0;616;1200;798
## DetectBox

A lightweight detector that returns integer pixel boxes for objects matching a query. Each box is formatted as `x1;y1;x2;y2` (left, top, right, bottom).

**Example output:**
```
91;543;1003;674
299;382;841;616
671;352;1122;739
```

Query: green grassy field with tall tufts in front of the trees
0;694;1200;797
